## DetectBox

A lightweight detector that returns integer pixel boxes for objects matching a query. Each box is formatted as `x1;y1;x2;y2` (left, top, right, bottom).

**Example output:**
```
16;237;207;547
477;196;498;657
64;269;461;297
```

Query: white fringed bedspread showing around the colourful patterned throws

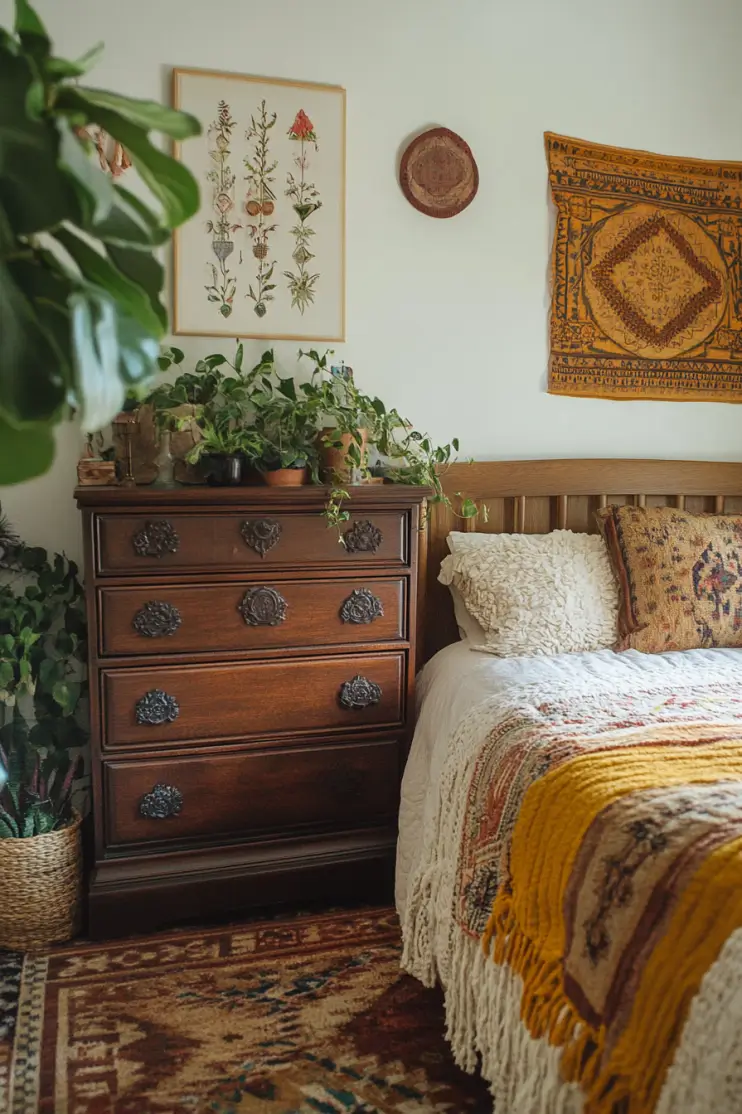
397;642;742;1114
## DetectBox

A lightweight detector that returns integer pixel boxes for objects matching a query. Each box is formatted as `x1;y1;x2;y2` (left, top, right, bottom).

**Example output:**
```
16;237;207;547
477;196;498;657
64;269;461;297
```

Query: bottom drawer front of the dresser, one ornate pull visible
105;741;399;846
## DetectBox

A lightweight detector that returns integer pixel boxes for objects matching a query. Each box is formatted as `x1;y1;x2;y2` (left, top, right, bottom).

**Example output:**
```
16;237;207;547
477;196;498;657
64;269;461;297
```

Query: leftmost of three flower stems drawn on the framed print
206;100;242;317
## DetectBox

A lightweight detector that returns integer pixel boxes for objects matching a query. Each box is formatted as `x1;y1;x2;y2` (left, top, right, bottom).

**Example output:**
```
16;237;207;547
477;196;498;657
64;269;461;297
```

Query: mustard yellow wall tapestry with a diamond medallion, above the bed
546;133;742;402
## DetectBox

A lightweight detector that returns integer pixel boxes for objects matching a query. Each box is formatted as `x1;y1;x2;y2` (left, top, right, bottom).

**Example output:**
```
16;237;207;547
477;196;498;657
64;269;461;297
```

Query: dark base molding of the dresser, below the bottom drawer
88;829;397;940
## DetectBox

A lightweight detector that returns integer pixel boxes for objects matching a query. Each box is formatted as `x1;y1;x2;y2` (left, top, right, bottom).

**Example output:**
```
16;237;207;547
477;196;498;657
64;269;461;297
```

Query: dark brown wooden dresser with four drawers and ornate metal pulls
76;486;426;938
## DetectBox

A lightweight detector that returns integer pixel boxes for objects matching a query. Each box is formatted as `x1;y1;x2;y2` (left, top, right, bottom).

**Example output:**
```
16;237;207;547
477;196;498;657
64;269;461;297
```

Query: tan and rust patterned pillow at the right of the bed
597;507;742;654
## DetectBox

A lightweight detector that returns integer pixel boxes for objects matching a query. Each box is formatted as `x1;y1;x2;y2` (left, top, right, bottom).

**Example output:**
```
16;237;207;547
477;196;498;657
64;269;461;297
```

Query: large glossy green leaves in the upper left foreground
0;0;201;485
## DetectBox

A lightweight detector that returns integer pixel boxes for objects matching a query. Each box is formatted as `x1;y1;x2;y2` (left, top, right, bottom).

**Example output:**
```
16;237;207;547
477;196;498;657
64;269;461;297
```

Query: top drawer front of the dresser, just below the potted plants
97;511;409;574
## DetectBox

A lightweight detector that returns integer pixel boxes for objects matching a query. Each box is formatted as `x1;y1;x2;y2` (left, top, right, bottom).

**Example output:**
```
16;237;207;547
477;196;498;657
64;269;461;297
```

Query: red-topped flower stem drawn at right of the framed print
284;108;322;314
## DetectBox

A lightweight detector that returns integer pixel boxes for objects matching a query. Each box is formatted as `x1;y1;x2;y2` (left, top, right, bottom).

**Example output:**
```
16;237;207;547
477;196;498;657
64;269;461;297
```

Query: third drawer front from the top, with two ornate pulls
101;653;404;747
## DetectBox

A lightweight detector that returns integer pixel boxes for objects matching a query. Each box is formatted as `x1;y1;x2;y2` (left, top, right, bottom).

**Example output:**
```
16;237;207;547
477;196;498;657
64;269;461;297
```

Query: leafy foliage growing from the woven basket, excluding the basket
0;515;88;837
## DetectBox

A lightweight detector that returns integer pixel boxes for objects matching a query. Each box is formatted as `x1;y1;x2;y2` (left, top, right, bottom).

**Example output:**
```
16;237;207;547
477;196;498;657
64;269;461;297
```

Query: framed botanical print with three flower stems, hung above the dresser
173;69;345;341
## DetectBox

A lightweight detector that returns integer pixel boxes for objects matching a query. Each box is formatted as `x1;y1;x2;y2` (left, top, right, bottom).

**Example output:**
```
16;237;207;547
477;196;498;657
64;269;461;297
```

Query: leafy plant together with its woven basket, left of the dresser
0;507;87;949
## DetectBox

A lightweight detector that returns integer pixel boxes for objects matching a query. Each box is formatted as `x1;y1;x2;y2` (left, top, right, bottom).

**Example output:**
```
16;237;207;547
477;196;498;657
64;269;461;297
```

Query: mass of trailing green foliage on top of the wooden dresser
148;343;479;527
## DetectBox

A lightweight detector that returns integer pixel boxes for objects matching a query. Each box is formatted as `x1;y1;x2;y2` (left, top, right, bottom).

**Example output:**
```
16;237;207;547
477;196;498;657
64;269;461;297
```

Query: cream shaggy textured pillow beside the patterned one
439;530;618;657
